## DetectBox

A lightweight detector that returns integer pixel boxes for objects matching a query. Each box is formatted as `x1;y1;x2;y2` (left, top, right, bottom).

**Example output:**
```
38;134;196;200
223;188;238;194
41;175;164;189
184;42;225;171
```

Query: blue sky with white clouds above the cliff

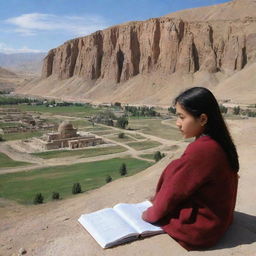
0;0;228;53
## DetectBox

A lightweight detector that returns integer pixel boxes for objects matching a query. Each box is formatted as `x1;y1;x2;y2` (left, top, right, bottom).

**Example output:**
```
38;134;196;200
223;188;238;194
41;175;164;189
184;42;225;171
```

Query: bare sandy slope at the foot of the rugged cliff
16;63;256;107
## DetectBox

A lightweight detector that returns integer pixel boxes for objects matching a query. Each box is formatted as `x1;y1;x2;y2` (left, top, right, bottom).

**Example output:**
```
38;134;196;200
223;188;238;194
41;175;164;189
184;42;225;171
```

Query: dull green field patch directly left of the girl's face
129;119;182;140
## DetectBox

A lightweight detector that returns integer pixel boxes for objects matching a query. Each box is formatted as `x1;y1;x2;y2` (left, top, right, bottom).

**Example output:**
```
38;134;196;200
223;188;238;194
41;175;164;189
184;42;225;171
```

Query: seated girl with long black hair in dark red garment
142;87;239;250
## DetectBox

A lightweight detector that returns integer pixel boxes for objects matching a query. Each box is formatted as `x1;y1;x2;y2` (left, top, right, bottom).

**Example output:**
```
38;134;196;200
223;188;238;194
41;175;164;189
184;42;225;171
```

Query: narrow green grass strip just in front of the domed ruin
32;146;127;159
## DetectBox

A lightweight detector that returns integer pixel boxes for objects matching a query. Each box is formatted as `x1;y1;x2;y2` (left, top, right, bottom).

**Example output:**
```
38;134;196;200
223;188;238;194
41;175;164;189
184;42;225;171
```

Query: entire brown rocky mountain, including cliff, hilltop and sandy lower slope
16;0;256;106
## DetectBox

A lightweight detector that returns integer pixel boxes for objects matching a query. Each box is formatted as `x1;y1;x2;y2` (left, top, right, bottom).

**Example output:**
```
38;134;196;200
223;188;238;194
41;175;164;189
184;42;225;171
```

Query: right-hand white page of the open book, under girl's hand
113;201;164;234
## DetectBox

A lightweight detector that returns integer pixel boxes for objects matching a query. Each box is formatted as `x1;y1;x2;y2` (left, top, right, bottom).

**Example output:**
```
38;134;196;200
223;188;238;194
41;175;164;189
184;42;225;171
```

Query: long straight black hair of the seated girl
173;87;239;172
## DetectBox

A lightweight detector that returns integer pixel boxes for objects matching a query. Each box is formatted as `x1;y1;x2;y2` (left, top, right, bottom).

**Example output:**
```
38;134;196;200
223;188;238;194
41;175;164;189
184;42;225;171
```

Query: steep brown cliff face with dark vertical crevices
42;17;256;83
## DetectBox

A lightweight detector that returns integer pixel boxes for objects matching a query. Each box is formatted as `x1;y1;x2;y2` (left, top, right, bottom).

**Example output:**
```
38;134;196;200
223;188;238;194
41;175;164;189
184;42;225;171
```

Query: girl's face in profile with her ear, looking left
175;103;207;139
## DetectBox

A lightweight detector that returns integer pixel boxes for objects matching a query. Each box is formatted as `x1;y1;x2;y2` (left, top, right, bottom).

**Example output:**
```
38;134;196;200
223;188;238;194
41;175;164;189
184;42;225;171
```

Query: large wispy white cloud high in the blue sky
5;13;108;36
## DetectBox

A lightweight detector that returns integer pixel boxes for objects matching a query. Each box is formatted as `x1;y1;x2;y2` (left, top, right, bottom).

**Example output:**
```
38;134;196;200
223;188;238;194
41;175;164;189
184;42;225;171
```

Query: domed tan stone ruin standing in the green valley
34;121;105;150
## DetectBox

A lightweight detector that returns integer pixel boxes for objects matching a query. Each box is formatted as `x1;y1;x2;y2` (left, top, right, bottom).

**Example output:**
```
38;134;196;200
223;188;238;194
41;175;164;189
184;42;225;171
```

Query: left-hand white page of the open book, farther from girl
78;208;138;248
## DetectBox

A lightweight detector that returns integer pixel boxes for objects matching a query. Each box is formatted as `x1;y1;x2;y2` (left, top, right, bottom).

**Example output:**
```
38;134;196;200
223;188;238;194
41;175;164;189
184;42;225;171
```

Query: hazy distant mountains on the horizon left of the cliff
0;53;46;74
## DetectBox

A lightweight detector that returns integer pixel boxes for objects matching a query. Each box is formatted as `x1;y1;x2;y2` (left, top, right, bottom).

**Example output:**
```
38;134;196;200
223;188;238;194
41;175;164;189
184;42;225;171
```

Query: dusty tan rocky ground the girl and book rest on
0;118;256;256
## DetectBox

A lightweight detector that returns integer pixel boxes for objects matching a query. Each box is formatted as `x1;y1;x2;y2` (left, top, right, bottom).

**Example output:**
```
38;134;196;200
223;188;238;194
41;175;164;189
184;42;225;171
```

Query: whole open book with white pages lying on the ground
78;201;164;248
